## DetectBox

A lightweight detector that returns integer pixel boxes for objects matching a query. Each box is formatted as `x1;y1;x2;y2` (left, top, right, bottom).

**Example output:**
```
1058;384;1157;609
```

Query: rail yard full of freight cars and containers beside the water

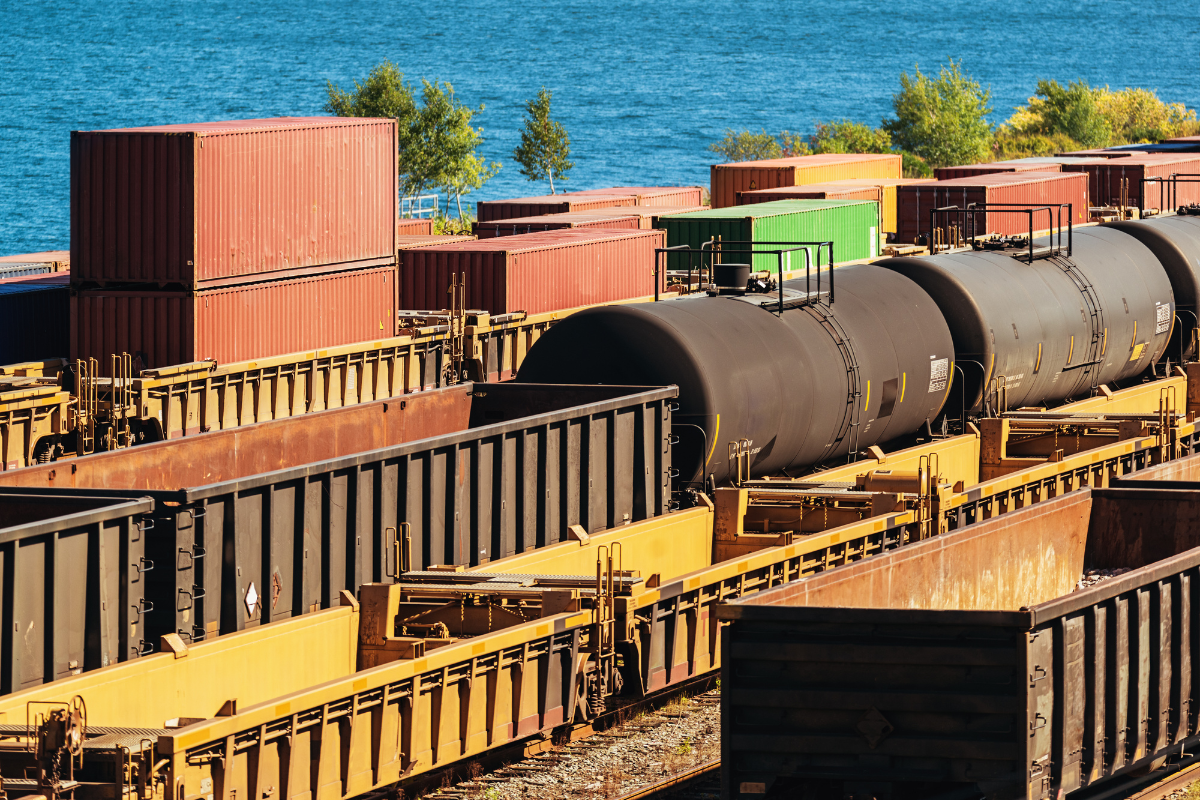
0;118;1200;800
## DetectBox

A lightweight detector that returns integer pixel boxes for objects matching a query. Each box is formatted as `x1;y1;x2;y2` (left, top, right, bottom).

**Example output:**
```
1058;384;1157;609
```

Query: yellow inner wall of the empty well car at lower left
0;603;359;728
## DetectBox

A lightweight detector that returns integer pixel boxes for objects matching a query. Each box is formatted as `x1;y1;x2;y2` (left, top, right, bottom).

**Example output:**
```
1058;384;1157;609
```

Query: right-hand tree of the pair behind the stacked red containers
413;80;500;219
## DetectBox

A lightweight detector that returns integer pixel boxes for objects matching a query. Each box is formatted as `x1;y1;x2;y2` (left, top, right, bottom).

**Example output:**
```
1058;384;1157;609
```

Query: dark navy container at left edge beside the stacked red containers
0;273;71;363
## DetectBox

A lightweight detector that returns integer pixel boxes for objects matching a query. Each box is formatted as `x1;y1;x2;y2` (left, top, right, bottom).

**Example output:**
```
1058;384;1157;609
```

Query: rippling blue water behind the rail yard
0;0;1200;253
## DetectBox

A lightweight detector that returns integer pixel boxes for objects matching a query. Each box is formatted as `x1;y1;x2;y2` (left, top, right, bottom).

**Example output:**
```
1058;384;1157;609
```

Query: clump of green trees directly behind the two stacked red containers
325;61;500;217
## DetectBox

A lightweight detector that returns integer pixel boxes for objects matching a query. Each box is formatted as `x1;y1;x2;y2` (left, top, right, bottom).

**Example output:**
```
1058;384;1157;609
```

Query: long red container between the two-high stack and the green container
400;228;666;314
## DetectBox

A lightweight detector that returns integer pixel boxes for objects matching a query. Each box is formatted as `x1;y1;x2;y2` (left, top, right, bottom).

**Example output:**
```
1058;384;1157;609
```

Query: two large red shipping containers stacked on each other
70;118;405;367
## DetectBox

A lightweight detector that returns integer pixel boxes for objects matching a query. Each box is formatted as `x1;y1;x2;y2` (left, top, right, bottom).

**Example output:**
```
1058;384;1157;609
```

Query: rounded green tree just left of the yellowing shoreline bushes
883;59;991;167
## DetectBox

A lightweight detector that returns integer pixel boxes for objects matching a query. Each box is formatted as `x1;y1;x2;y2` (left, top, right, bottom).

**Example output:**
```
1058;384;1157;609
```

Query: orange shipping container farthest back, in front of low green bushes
712;154;901;209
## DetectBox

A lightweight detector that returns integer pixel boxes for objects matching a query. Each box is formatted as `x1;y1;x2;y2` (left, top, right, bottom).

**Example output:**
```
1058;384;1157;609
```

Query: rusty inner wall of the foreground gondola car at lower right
746;489;1092;610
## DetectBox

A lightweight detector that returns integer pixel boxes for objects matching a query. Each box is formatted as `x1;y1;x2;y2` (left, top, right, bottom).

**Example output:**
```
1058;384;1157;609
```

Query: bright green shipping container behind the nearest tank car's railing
659;200;880;272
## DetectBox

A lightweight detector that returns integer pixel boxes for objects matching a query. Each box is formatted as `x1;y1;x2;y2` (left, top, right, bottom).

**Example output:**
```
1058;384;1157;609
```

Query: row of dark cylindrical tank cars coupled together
518;216;1200;488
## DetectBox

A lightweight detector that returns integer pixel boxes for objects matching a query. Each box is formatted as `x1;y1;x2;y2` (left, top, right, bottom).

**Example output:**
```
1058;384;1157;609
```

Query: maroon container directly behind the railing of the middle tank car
896;173;1090;243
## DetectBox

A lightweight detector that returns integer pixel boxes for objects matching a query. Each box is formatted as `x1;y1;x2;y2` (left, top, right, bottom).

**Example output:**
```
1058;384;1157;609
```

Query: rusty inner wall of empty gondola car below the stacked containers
0;386;472;491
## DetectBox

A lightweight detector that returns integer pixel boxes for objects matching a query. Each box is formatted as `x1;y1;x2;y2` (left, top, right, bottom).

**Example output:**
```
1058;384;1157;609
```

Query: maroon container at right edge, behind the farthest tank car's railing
1063;152;1200;210
